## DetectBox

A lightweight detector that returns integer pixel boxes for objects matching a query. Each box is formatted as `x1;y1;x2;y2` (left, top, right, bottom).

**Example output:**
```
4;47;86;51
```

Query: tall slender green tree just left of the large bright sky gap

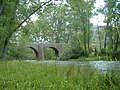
67;0;95;52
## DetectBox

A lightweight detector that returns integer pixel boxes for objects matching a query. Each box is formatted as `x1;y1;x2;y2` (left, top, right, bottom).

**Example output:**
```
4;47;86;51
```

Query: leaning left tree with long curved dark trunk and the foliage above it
0;0;51;58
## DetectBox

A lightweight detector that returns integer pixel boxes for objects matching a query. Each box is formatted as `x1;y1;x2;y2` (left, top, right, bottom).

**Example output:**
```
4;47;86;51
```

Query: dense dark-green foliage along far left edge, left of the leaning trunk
0;0;19;57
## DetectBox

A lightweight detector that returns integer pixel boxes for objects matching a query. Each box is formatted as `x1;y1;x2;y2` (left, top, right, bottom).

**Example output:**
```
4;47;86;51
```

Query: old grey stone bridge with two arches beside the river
27;43;64;60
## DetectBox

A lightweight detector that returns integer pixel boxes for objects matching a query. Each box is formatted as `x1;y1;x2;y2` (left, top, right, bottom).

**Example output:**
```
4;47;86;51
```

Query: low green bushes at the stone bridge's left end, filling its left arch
6;43;36;60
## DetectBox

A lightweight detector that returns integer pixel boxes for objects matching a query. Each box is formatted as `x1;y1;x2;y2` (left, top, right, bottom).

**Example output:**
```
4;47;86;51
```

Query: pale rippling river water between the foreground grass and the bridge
26;60;120;71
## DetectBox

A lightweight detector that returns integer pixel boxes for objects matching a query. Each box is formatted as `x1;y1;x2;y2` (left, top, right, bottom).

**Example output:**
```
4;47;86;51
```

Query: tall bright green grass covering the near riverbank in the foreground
0;60;120;90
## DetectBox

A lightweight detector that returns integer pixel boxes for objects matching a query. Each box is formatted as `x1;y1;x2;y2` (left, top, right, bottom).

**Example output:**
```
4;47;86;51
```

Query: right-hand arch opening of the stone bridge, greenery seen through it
45;47;59;60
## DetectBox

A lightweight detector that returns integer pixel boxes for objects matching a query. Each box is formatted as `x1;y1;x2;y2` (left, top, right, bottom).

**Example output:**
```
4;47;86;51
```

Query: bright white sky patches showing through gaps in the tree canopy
31;0;106;26
